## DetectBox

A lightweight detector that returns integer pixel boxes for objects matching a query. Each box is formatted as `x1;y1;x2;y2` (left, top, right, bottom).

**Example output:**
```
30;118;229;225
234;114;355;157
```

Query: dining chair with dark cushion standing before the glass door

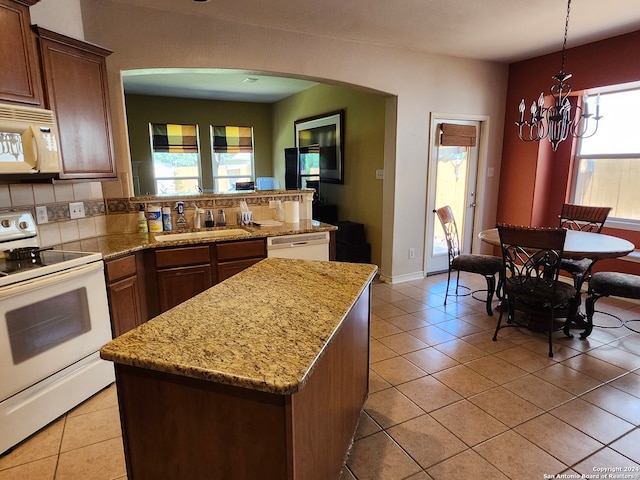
433;205;502;315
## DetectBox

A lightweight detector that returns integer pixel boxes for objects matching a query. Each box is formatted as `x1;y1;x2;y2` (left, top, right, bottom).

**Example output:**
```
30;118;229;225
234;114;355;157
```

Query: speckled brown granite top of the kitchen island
100;258;377;395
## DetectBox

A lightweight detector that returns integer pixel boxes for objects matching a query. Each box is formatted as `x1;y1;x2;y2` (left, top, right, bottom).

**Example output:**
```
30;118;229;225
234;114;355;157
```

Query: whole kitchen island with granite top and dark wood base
101;258;377;480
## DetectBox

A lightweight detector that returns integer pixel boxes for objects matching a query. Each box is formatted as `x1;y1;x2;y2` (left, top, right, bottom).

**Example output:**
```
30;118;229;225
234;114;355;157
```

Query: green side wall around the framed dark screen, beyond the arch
273;84;386;265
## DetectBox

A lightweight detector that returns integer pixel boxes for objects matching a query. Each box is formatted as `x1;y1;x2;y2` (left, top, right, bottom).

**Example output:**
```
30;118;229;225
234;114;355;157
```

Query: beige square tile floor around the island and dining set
0;275;640;480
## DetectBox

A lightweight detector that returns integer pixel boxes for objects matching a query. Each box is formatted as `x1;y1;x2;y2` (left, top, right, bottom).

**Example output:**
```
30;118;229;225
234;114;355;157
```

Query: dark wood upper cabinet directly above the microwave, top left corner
0;0;42;107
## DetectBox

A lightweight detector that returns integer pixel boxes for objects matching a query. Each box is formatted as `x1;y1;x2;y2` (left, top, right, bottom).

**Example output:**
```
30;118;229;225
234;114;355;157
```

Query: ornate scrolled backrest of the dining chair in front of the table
497;223;567;296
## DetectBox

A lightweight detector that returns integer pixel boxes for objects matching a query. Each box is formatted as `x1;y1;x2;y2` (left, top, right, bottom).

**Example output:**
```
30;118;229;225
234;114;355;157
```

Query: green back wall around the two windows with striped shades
125;95;273;195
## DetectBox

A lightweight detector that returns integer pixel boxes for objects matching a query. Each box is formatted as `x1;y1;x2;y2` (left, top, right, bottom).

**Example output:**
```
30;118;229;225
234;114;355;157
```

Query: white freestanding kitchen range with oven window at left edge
0;212;115;454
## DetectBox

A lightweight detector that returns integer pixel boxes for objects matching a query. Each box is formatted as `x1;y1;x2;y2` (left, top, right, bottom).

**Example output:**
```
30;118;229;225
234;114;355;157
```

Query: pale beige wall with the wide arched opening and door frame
77;0;507;282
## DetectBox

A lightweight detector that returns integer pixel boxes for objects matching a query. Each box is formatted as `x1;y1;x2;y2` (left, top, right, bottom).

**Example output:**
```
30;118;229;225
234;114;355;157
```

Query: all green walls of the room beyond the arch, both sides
125;84;386;265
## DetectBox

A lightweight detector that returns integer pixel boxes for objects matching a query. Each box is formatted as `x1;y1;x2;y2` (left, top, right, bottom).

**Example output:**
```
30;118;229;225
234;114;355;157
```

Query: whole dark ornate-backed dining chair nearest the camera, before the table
493;223;577;357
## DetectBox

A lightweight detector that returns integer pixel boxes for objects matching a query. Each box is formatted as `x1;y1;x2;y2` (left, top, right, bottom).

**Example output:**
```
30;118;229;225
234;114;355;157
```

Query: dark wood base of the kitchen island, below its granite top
110;286;371;480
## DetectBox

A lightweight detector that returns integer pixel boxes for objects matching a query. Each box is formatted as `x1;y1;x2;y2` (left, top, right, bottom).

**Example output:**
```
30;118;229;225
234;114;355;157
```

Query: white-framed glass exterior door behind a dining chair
425;119;480;273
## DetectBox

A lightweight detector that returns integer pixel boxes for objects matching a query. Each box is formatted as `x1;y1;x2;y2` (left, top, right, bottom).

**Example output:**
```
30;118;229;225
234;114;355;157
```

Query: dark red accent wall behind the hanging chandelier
496;31;640;274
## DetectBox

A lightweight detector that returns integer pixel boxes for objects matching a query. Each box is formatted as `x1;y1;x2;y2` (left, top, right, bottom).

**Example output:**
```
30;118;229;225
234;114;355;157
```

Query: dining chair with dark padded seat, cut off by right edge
581;272;640;338
